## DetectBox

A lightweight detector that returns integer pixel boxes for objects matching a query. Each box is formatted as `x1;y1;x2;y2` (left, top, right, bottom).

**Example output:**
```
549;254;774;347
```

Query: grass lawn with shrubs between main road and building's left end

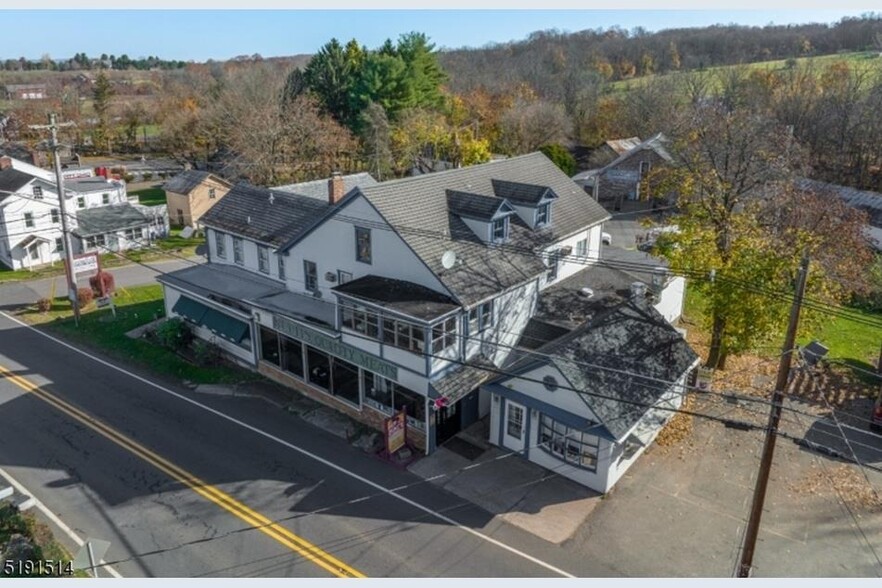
19;284;259;384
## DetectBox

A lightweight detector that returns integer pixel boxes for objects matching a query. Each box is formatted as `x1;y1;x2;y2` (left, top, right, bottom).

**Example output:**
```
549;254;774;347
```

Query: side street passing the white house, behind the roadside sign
0;257;204;310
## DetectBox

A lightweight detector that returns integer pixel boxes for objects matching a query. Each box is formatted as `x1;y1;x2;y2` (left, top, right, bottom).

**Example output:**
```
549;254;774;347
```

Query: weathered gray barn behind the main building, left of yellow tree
573;133;673;210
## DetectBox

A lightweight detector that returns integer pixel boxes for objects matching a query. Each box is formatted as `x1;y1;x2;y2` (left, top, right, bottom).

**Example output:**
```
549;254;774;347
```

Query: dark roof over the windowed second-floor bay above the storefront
334;275;458;320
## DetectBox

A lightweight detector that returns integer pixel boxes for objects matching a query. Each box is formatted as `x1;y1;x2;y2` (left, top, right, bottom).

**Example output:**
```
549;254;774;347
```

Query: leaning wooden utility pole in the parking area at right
738;255;809;578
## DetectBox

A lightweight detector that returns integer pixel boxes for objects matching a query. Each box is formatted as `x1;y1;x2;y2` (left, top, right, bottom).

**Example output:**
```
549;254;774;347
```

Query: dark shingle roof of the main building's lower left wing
202;183;330;247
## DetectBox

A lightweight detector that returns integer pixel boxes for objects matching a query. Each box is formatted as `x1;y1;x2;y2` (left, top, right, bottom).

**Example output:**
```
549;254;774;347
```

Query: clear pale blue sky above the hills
0;8;878;61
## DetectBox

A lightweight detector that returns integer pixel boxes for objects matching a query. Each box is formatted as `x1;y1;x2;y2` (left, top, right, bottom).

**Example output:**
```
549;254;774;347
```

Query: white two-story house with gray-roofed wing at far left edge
0;157;152;269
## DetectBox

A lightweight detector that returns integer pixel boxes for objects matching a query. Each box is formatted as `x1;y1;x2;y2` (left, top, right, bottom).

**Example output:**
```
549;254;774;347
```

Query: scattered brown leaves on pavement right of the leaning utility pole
790;463;882;512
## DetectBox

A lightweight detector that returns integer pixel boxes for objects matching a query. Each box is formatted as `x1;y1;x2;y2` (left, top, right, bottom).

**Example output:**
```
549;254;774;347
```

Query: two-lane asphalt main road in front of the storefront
0;314;610;577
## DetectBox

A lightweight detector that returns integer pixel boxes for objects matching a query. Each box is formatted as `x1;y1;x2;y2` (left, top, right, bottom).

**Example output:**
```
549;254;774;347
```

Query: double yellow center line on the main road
0;365;365;578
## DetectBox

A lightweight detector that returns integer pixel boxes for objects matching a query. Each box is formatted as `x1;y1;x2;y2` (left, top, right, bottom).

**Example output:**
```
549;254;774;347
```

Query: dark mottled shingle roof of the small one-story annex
509;300;698;439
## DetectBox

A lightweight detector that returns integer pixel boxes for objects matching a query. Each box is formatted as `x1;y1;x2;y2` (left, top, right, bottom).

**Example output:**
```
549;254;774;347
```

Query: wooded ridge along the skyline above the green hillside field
440;13;882;93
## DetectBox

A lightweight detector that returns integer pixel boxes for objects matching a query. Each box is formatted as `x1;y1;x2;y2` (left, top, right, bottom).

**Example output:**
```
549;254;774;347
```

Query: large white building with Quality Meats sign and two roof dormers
157;153;609;452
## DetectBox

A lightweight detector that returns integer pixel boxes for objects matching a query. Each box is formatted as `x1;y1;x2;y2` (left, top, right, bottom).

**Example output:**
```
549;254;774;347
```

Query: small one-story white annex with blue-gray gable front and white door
483;296;699;493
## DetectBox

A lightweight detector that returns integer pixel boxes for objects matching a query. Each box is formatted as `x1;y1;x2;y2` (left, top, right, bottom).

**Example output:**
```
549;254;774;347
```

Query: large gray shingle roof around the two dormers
359;153;609;306
